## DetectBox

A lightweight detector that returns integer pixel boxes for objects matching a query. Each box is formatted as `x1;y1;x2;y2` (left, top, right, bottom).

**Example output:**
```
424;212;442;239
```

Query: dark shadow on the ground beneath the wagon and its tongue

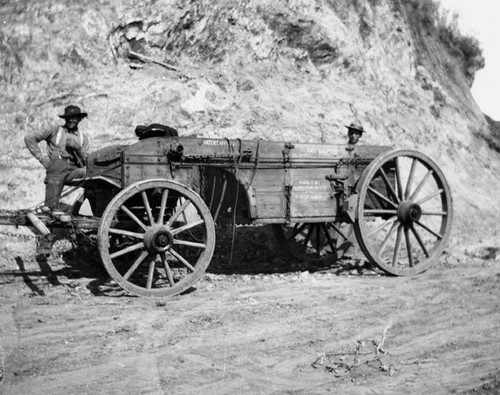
0;227;378;296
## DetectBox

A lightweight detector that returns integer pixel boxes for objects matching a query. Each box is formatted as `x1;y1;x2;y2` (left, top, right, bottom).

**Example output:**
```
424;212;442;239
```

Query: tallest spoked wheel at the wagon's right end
354;150;453;276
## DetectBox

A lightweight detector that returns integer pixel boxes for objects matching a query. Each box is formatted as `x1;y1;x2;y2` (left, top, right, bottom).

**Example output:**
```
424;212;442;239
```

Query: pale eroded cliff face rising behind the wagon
0;0;500;235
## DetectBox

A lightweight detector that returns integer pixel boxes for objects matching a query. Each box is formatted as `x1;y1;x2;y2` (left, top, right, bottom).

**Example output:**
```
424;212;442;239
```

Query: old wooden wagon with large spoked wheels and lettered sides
3;125;452;297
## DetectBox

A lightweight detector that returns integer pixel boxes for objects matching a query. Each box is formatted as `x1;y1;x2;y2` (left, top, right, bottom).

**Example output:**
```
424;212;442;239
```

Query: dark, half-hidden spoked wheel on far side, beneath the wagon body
273;222;353;266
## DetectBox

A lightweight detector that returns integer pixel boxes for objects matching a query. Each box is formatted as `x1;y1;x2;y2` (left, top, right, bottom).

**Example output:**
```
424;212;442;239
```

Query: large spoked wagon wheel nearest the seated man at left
98;179;215;297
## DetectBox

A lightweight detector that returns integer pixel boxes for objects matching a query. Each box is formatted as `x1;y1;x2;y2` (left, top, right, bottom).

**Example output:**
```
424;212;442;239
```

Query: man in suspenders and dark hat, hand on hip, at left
24;105;89;210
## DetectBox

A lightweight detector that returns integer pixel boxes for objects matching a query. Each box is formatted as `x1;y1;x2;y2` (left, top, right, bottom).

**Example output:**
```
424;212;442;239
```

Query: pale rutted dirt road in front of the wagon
0;227;500;395
